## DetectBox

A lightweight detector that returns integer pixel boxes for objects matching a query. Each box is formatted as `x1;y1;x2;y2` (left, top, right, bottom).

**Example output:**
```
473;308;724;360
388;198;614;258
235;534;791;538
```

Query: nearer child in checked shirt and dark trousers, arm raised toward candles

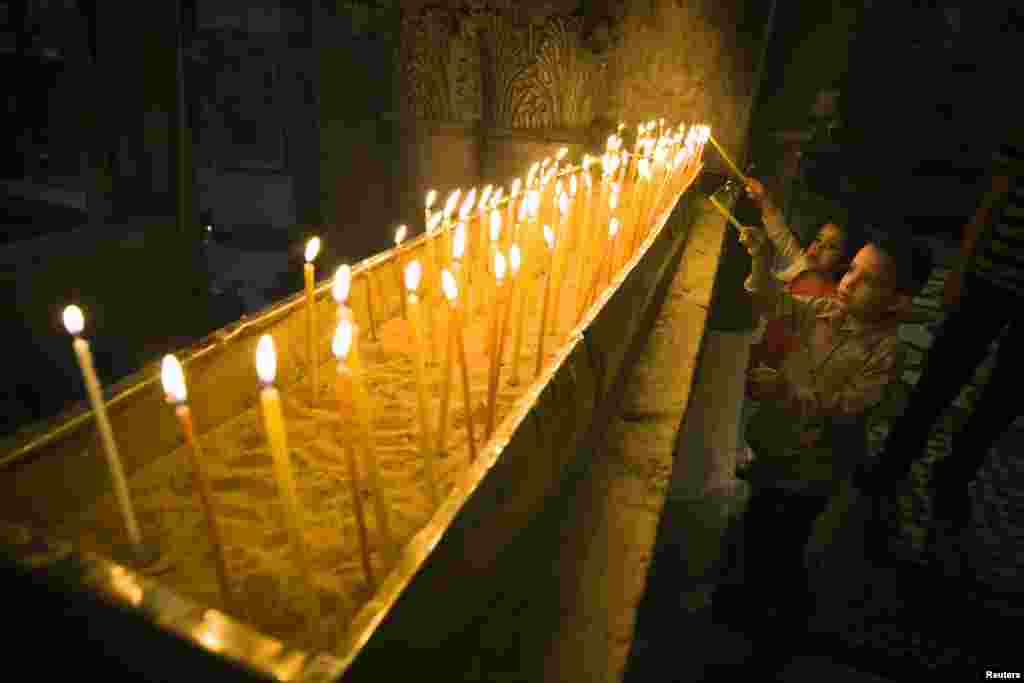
716;222;931;659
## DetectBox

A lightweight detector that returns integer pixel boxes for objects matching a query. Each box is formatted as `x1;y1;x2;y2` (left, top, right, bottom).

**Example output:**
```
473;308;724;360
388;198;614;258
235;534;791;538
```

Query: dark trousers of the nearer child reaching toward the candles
743;487;828;622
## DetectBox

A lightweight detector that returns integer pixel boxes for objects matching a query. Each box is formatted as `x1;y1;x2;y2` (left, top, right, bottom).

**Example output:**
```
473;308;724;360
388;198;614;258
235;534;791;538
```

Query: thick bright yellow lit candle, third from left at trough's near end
256;335;319;635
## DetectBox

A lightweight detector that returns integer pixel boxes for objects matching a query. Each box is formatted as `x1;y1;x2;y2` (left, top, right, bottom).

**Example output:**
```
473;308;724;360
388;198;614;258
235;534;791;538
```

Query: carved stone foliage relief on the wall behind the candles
402;2;603;128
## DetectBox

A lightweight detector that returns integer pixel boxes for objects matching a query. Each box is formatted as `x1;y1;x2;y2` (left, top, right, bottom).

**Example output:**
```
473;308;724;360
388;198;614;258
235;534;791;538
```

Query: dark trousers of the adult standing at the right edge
881;273;1024;525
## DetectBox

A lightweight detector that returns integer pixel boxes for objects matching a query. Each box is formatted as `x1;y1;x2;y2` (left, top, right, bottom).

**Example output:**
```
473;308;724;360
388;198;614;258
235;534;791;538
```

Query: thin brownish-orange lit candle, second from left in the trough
160;354;234;610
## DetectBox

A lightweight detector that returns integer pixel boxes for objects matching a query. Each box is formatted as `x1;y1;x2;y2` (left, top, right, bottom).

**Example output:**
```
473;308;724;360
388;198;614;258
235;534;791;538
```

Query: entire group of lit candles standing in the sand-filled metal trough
63;120;717;643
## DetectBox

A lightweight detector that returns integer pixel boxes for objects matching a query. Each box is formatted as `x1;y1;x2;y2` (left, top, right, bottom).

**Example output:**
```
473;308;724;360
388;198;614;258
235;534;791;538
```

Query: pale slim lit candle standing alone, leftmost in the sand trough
63;305;148;563
